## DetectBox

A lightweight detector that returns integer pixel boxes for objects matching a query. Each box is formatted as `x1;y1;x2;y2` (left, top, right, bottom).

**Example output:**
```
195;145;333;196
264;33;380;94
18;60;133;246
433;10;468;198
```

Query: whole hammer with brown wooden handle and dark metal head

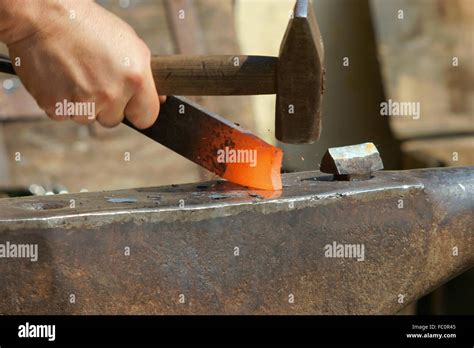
151;0;324;144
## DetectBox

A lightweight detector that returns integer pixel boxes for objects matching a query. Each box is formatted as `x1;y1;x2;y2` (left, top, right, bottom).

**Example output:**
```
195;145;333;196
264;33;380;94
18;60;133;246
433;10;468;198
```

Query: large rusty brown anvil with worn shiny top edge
0;167;474;314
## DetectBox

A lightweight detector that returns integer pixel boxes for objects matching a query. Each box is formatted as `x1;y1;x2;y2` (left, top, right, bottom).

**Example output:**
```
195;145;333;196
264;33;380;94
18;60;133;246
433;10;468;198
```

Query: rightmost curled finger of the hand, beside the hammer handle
125;70;160;129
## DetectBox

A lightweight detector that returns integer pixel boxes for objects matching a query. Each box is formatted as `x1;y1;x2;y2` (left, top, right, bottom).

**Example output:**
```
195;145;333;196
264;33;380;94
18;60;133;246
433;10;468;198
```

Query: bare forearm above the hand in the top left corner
0;0;89;45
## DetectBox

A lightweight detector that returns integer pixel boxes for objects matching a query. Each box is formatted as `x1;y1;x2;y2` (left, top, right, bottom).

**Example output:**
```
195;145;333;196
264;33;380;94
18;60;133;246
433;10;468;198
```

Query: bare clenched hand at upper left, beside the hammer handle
3;0;163;129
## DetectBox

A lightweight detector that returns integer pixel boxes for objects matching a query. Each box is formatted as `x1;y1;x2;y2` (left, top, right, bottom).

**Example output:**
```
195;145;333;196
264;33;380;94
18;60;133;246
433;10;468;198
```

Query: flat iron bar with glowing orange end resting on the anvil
124;96;283;190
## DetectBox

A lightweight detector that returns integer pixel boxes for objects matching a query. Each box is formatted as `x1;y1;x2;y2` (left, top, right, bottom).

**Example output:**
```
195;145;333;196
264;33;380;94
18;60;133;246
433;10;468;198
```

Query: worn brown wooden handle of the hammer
151;55;278;96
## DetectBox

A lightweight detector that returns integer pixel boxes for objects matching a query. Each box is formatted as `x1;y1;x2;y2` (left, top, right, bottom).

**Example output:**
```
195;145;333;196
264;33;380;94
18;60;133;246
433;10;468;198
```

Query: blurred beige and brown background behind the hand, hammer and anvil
0;0;474;314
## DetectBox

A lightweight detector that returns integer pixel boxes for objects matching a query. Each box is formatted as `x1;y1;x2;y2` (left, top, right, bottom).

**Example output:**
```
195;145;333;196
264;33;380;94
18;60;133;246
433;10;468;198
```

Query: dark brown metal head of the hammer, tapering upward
275;0;324;144
